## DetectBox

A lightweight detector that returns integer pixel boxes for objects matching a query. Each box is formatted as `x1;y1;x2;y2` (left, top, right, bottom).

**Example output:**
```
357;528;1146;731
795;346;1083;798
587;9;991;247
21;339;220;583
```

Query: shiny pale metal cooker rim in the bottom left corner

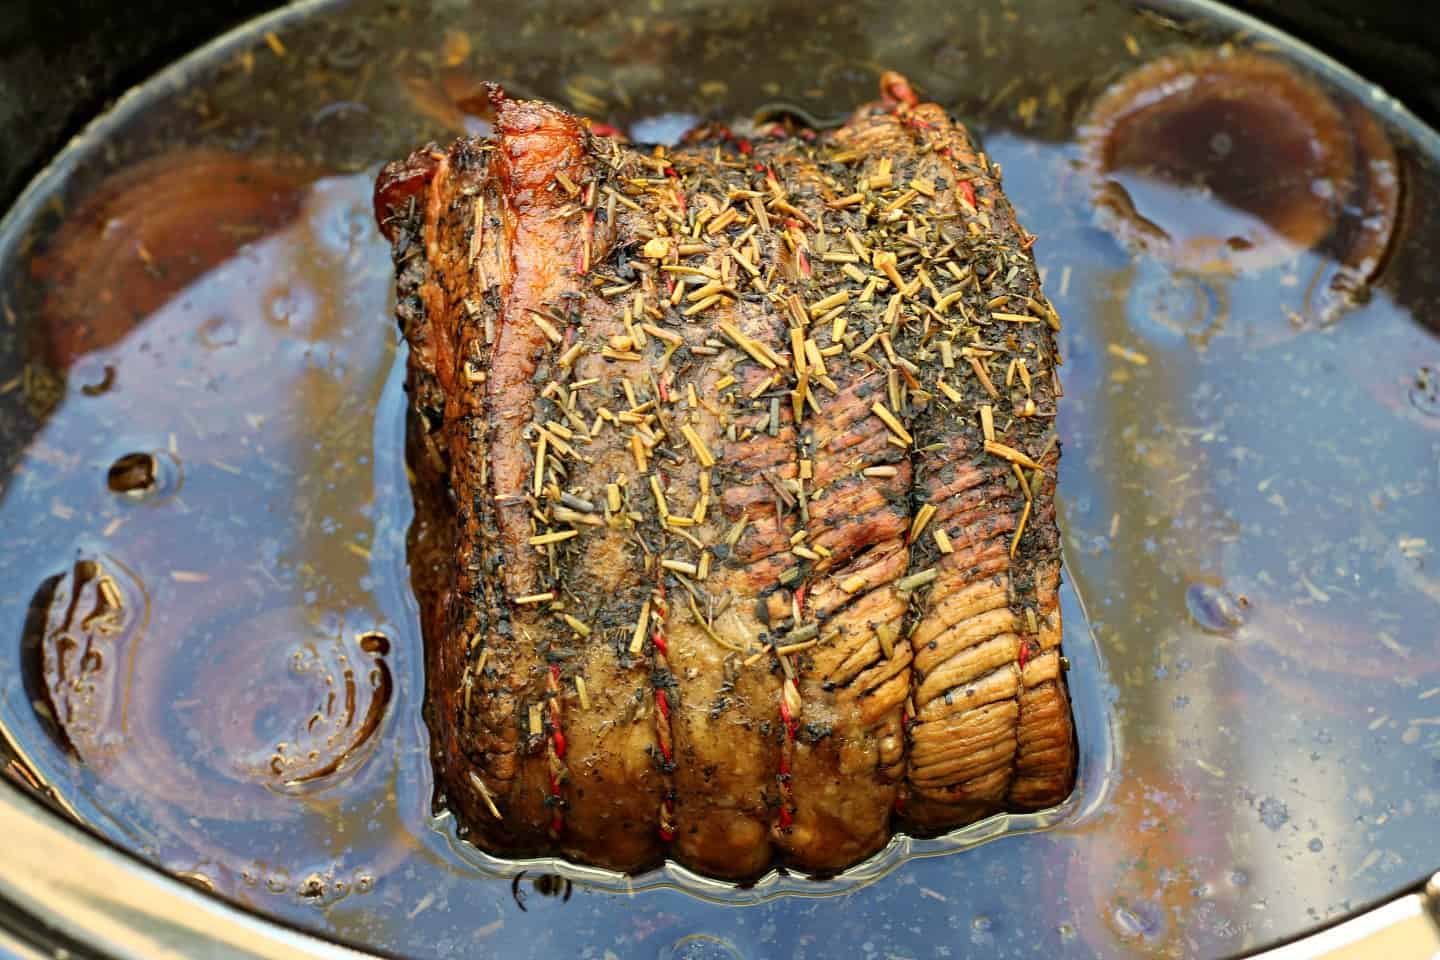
0;786;374;960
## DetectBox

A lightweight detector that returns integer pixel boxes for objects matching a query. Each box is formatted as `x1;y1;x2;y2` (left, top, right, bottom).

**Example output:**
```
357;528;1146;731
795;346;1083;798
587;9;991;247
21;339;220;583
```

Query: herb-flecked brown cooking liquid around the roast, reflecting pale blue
0;0;1440;957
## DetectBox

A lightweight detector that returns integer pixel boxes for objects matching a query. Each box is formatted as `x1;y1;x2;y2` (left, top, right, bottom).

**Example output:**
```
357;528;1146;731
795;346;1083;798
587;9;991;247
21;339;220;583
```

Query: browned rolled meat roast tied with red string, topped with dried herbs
376;75;1076;879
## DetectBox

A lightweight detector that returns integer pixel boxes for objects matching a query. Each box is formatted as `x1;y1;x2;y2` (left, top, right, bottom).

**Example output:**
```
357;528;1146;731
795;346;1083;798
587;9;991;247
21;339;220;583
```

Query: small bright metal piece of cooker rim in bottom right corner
1251;874;1440;960
